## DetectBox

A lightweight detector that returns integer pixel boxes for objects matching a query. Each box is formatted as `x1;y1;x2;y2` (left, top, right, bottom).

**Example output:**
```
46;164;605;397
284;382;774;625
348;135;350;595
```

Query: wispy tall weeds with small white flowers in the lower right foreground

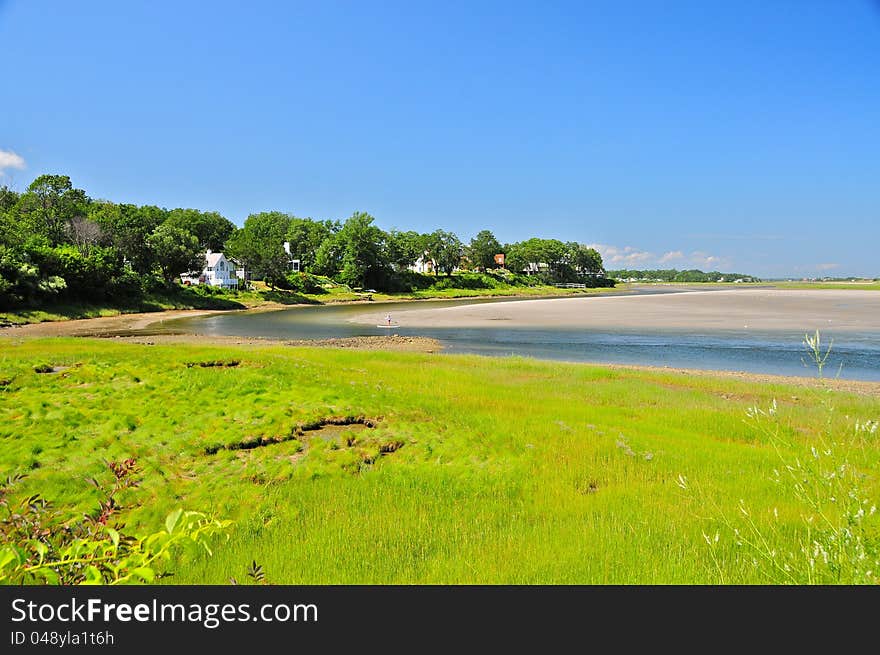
692;330;880;584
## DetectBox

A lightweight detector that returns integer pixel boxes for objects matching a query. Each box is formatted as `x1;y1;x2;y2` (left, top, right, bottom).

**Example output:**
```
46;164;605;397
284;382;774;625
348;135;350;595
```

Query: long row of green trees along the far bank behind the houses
0;175;604;307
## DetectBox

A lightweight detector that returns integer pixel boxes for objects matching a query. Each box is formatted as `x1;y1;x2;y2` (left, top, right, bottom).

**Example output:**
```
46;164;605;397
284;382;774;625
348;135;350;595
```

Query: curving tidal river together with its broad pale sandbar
155;288;880;381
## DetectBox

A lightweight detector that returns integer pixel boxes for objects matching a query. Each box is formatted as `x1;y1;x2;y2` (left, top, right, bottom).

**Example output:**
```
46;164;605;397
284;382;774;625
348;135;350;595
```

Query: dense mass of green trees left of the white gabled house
0;175;235;309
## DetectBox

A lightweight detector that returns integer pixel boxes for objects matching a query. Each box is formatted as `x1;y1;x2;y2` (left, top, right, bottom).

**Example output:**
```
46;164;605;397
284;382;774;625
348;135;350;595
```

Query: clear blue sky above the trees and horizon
0;0;880;276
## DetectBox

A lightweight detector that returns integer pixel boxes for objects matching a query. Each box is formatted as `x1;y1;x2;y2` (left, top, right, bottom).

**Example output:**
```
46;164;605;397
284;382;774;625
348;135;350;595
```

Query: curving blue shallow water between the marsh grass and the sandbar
154;290;880;381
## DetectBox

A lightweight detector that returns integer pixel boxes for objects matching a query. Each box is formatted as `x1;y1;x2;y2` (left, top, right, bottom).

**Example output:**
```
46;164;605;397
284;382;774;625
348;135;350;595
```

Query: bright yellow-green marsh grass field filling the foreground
0;339;880;584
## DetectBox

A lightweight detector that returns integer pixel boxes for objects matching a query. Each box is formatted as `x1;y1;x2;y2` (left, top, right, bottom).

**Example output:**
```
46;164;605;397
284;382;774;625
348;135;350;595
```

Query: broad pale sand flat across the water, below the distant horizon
352;289;880;332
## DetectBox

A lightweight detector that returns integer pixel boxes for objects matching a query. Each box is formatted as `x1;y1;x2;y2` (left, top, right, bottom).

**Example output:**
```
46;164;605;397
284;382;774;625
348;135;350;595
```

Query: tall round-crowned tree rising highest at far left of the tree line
18;175;88;246
